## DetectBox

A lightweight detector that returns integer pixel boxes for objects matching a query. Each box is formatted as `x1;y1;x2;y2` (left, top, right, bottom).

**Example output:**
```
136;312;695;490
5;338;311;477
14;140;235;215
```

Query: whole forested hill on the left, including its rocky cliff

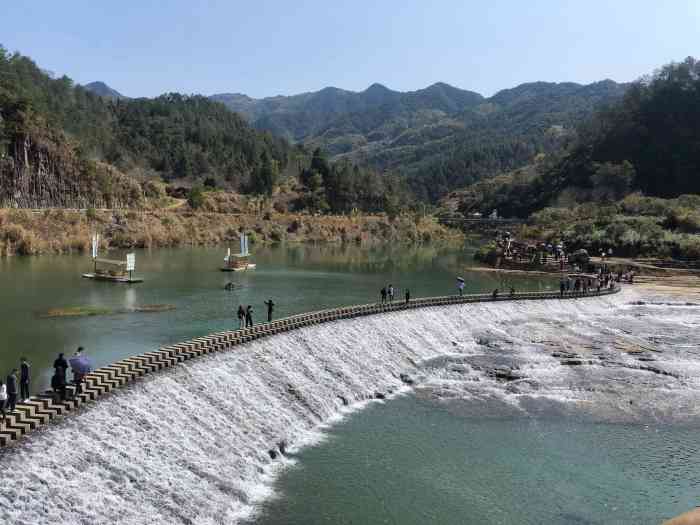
0;47;410;213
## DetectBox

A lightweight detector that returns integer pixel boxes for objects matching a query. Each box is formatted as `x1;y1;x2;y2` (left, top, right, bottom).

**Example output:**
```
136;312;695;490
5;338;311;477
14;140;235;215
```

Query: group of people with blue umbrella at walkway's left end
0;346;90;423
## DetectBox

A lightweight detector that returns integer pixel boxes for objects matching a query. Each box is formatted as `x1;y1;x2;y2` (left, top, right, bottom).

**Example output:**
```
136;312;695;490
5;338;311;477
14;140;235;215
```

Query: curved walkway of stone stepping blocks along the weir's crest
0;287;620;447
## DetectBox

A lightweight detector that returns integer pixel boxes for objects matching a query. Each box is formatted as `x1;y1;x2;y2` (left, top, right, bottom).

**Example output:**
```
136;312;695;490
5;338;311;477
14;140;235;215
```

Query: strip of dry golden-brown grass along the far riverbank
0;209;464;256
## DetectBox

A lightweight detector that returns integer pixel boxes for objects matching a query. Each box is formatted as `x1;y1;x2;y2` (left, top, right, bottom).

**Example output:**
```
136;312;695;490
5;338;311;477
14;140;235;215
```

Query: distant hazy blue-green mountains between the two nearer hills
212;81;625;201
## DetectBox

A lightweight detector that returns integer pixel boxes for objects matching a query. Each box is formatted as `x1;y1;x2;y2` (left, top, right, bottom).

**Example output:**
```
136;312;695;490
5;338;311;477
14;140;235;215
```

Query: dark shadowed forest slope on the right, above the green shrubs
452;57;700;217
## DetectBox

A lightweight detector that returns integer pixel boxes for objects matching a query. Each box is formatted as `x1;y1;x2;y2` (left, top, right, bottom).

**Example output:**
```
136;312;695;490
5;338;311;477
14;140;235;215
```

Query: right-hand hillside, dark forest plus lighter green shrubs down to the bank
443;58;700;259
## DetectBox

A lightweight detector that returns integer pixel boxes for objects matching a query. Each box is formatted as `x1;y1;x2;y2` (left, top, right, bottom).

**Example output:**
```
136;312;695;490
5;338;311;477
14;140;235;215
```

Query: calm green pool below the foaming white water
255;395;700;525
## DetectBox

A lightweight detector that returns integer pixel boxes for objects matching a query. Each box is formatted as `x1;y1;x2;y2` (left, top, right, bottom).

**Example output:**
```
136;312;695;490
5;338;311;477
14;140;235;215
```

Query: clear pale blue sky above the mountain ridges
0;0;700;98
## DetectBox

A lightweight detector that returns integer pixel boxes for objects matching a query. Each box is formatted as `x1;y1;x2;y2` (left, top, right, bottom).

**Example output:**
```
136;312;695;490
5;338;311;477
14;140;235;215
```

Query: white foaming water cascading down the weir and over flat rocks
0;291;700;525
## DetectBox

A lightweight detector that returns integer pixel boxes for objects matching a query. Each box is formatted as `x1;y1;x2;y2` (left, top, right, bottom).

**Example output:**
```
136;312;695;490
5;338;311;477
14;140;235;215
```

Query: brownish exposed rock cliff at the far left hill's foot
0;128;143;208
